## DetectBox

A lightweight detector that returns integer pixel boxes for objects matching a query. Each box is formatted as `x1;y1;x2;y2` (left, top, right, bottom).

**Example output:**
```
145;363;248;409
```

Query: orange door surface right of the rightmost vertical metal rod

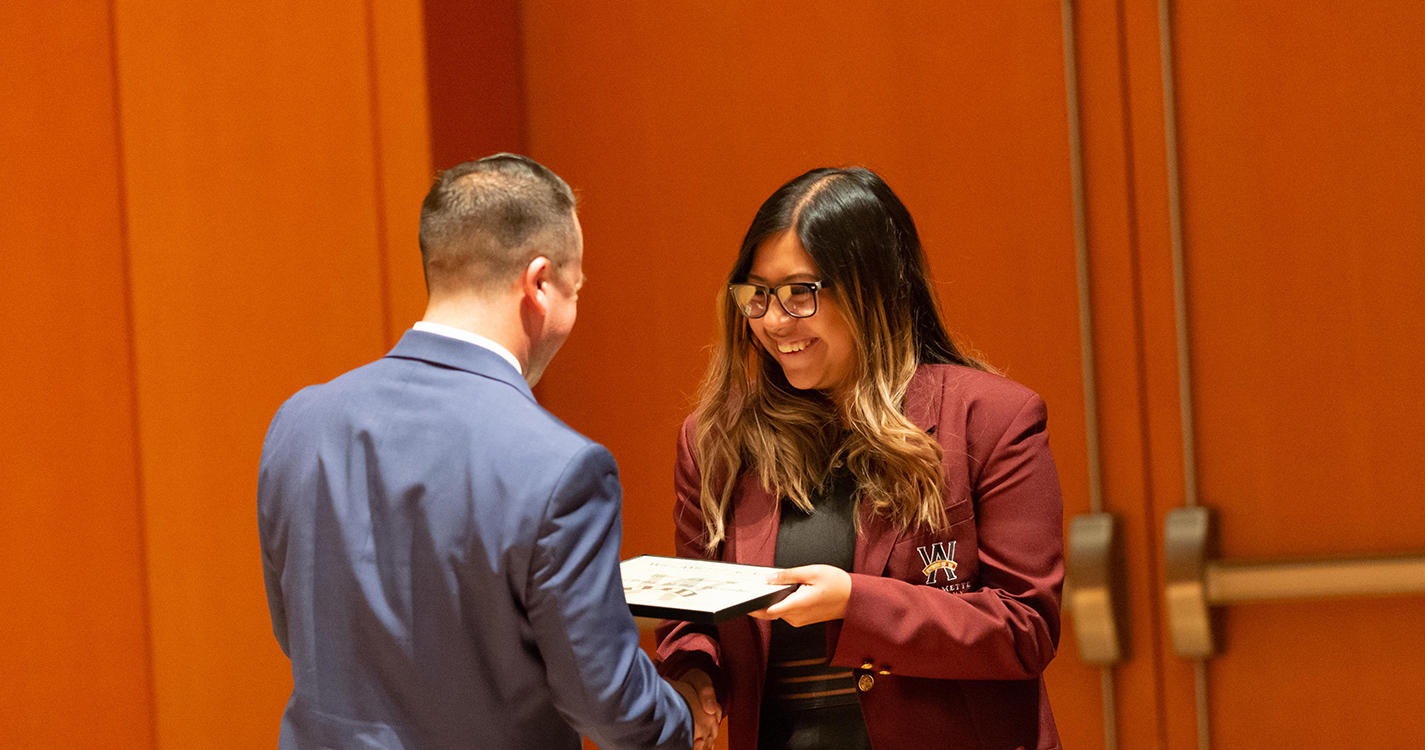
1156;0;1425;747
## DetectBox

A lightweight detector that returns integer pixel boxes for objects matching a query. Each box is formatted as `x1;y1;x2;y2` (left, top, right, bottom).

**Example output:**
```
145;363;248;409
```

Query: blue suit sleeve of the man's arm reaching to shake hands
526;445;693;750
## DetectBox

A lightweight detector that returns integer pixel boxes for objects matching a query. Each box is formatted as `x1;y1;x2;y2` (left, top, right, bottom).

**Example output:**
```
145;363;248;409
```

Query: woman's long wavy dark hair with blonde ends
694;167;989;553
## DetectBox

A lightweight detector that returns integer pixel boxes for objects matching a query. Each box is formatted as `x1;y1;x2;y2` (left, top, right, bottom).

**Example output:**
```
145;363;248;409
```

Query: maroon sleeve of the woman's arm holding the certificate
832;395;1063;680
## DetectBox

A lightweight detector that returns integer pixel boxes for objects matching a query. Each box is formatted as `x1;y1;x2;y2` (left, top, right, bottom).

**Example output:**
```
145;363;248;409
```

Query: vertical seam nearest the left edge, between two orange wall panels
108;0;158;750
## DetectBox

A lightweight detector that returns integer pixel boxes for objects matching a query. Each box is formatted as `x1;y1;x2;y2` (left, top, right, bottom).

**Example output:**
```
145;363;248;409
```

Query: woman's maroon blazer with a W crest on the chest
658;365;1063;750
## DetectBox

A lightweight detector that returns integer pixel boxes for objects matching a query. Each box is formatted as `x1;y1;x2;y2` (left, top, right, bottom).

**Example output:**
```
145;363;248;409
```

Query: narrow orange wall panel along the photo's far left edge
0;3;152;750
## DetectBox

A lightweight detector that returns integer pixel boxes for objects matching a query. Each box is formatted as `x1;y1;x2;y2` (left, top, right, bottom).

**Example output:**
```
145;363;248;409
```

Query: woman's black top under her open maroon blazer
758;466;869;750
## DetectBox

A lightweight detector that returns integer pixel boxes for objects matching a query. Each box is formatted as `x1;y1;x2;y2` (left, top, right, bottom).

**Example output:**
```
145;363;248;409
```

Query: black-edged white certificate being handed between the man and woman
618;555;797;625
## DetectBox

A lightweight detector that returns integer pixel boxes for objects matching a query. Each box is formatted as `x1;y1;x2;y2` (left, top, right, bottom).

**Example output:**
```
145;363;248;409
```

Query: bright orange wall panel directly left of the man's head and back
107;0;425;749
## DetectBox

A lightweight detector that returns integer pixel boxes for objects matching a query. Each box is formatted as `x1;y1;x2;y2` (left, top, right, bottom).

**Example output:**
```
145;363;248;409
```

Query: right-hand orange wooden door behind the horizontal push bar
1067;1;1425;749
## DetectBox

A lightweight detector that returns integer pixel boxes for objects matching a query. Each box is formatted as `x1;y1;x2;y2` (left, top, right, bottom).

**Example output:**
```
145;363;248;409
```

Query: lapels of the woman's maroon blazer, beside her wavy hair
728;365;945;576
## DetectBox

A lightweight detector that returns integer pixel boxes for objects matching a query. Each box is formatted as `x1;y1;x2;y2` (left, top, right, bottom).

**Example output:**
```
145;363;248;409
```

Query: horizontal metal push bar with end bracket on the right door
1163;506;1425;659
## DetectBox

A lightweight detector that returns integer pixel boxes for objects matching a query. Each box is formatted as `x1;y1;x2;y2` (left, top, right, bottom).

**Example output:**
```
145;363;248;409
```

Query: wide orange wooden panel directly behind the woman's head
524;3;1083;558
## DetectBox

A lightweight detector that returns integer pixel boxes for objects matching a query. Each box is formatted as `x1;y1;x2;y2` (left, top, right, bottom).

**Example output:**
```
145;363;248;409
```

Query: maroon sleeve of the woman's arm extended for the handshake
657;418;730;707
